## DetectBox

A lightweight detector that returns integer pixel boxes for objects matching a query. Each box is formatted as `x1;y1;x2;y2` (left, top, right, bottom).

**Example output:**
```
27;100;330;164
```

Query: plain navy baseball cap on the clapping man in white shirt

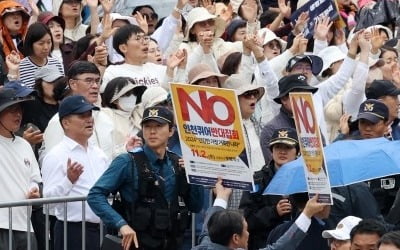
58;95;100;120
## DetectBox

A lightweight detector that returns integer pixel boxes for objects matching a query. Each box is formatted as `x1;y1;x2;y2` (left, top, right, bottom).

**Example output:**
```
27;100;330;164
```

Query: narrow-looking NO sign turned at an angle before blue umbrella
289;93;333;204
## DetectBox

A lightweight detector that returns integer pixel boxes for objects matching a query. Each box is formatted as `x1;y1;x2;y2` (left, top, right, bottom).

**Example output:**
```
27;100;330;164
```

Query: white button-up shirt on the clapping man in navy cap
42;136;109;223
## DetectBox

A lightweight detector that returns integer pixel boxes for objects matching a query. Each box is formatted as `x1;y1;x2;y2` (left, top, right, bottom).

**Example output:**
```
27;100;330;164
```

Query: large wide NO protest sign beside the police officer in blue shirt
171;83;253;190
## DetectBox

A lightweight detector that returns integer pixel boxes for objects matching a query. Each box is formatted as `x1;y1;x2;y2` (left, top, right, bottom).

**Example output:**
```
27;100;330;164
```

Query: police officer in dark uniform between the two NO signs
239;128;300;250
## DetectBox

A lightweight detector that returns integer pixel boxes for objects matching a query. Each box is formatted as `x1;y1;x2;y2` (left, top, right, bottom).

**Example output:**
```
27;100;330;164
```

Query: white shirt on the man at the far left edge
0;135;42;232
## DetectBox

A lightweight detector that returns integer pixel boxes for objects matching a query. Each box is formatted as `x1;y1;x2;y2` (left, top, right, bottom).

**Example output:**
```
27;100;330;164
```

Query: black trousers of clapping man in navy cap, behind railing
54;220;100;250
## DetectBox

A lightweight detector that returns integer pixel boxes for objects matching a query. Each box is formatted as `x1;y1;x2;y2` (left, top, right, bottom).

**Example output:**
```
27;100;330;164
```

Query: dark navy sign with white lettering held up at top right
290;0;339;39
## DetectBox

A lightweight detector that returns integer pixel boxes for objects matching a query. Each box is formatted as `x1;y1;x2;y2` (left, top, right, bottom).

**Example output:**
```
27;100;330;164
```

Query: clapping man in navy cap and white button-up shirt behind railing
42;95;109;250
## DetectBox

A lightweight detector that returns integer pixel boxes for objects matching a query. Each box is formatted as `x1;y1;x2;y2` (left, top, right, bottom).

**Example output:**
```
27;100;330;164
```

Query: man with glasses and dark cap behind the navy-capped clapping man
40;61;113;159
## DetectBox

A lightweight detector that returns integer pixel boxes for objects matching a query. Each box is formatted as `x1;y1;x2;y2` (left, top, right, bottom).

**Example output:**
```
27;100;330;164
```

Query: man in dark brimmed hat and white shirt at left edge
0;88;41;250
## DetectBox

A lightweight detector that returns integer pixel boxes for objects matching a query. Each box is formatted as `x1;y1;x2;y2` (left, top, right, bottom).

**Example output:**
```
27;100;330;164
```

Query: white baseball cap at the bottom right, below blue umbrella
322;216;361;240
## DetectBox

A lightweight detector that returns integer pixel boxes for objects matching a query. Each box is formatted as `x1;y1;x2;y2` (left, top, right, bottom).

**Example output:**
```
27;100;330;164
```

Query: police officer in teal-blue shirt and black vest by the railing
88;106;203;250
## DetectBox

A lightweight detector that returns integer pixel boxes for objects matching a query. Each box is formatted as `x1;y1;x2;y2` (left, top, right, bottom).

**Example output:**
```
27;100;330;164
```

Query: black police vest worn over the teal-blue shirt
125;151;190;250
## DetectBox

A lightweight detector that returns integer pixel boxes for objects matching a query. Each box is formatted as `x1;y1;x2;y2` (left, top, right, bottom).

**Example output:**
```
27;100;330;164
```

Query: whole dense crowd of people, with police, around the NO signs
0;0;400;250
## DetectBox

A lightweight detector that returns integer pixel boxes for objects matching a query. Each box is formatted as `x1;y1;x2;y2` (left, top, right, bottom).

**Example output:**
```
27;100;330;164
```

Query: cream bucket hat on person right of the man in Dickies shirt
184;7;226;41
